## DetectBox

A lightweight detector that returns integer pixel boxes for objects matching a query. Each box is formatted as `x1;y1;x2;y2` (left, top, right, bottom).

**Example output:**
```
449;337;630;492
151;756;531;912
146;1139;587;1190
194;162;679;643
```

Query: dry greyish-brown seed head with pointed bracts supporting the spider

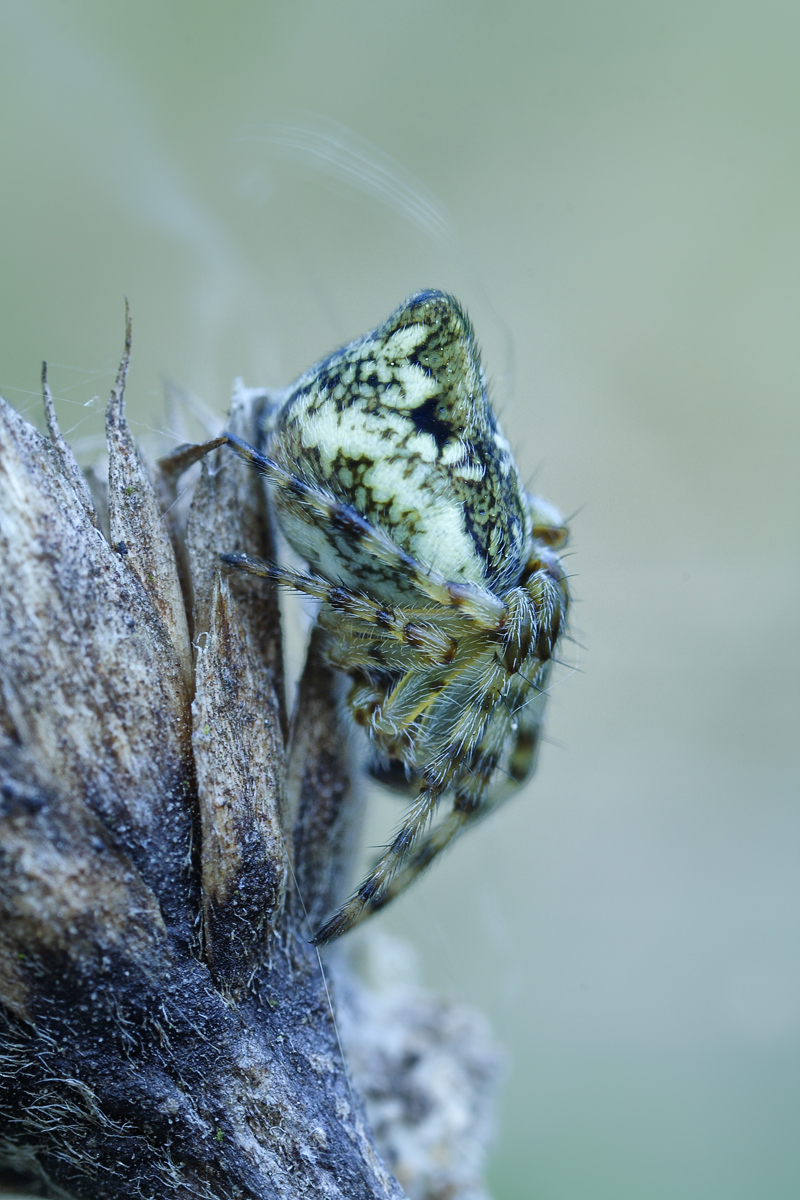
0;338;495;1200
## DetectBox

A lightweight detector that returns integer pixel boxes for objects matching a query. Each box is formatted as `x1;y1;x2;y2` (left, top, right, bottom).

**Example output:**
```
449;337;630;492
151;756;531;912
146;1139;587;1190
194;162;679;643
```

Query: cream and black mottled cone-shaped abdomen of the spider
269;292;530;595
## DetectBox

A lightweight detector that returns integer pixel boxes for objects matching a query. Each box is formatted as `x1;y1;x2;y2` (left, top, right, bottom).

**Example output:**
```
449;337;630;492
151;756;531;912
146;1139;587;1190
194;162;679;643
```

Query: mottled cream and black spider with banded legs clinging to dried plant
194;290;569;944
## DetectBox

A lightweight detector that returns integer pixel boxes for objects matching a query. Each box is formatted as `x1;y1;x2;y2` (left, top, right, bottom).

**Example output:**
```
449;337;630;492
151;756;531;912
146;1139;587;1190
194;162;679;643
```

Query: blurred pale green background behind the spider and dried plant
0;0;800;1200
